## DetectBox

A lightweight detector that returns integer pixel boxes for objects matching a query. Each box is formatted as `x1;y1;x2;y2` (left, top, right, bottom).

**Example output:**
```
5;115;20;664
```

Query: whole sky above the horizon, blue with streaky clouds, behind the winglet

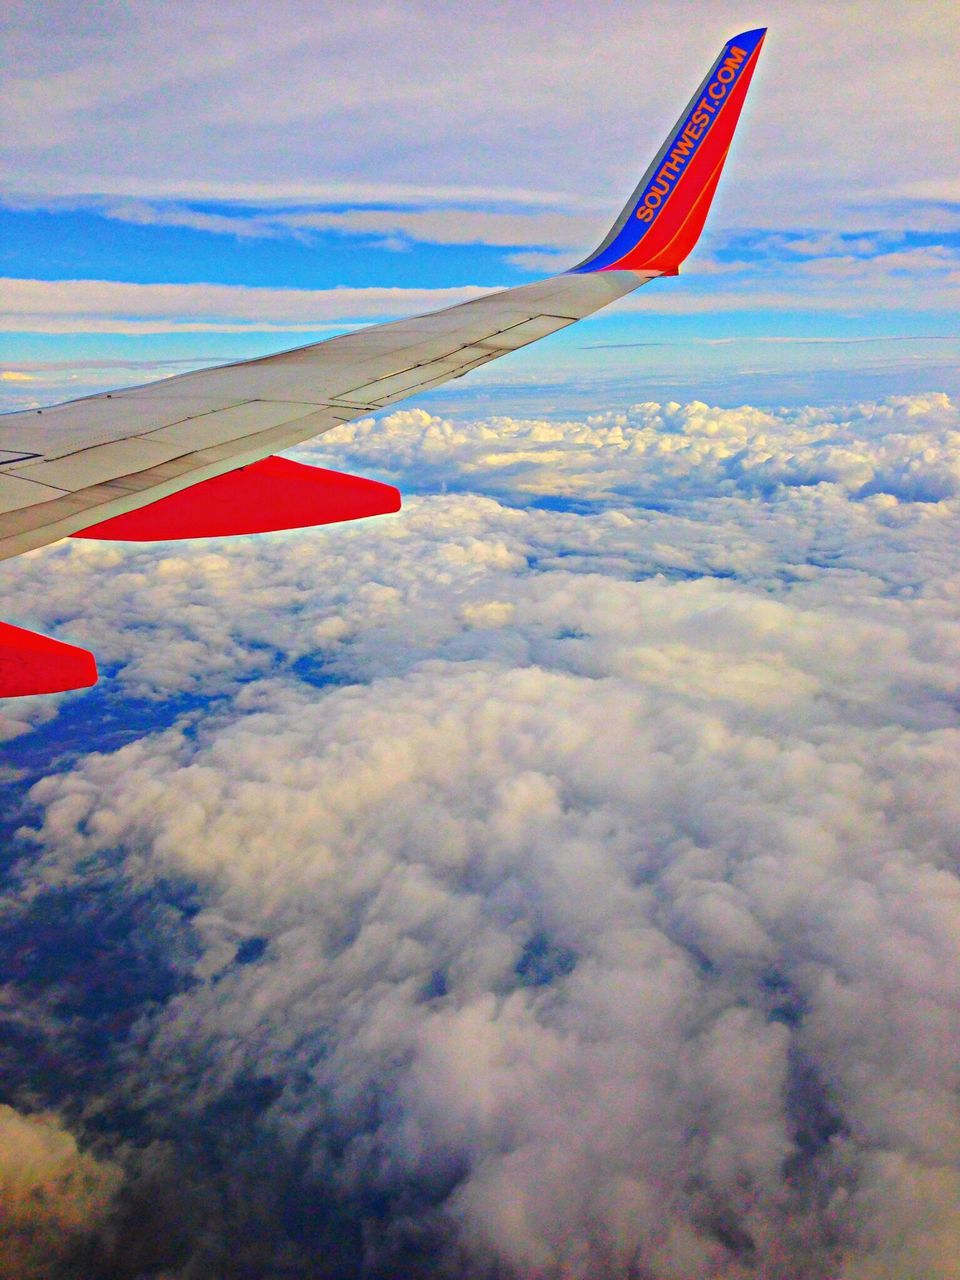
0;0;960;411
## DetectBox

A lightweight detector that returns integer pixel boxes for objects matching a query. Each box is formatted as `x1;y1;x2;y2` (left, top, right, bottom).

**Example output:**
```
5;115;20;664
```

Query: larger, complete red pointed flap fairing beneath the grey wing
73;458;401;543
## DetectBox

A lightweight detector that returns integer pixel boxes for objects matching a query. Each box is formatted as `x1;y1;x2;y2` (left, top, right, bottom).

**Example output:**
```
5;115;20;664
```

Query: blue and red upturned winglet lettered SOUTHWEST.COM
572;27;767;275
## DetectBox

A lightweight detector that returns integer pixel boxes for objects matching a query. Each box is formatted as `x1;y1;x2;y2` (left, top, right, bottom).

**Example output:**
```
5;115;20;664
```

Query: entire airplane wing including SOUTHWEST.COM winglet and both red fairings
0;29;765;696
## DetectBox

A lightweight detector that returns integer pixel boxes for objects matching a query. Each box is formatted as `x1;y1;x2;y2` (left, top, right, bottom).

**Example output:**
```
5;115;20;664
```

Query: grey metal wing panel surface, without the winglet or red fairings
0;271;650;559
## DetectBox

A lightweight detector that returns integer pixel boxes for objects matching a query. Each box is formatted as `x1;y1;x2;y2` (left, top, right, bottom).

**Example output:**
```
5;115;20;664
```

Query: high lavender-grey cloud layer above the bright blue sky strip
3;0;956;244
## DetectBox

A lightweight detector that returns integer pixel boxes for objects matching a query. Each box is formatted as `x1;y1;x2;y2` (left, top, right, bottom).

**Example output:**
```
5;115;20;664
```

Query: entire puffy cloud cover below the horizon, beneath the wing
0;396;960;1280
